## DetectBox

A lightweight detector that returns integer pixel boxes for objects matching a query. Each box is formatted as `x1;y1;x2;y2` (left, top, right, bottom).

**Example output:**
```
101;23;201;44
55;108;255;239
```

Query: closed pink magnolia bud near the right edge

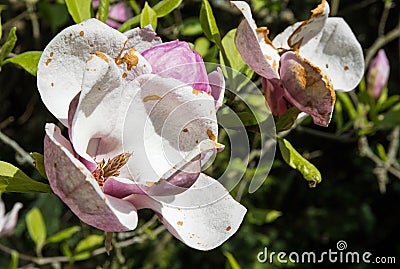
367;49;390;99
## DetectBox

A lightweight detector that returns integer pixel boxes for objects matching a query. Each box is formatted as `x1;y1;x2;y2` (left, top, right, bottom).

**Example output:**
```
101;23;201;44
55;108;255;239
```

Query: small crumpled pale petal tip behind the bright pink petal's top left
124;25;162;53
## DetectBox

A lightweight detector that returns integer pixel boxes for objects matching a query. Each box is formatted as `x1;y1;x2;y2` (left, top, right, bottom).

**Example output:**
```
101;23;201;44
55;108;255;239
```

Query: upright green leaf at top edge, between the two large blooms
200;0;221;44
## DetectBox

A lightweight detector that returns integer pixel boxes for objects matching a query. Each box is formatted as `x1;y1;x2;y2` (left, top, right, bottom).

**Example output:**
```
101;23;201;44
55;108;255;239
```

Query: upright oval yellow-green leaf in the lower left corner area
25;207;46;253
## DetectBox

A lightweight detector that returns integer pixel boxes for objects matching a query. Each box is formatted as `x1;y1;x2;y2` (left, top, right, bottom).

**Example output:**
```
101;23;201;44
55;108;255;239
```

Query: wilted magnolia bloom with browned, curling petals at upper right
231;0;364;126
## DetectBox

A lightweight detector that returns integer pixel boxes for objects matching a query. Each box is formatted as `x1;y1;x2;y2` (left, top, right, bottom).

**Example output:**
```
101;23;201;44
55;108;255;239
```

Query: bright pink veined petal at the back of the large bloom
142;40;211;93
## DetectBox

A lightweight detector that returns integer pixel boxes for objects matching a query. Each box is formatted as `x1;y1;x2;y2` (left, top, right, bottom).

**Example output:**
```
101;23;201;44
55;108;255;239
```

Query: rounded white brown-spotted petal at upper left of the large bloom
37;19;127;125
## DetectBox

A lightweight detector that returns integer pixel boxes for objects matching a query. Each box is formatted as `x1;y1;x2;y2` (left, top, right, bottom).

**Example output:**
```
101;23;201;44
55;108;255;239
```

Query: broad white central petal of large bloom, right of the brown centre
124;75;221;183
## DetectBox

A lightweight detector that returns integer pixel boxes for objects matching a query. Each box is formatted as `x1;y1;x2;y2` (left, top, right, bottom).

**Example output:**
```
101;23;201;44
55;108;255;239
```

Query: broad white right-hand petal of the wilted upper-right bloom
300;18;364;91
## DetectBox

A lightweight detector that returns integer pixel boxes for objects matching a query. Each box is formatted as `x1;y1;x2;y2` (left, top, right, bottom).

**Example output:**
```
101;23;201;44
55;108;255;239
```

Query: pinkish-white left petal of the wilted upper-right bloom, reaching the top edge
231;1;279;79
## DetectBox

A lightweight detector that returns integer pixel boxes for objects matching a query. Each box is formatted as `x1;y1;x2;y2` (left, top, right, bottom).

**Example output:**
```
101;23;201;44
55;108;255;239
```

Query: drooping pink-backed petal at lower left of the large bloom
44;124;137;232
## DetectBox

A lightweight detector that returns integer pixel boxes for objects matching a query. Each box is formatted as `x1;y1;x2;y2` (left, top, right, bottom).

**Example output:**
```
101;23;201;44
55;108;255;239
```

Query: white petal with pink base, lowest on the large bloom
127;174;246;250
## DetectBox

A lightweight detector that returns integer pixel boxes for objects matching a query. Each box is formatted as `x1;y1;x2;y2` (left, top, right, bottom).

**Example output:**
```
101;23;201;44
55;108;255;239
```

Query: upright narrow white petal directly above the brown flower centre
71;52;124;161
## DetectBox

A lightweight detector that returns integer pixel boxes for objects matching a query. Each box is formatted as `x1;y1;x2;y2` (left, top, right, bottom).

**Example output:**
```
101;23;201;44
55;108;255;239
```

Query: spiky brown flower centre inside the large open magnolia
93;153;132;187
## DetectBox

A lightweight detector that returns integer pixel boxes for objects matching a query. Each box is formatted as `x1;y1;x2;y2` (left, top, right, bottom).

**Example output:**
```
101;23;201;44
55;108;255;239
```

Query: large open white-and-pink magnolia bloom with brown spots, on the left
38;19;246;250
